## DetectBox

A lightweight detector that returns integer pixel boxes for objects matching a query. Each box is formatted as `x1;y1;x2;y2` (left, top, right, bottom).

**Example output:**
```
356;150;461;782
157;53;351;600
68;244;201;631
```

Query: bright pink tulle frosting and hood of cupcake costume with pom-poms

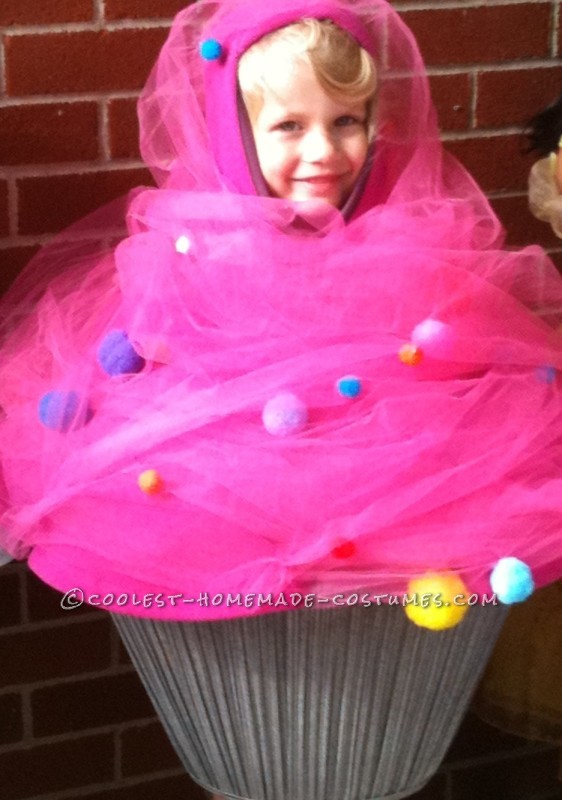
0;0;562;620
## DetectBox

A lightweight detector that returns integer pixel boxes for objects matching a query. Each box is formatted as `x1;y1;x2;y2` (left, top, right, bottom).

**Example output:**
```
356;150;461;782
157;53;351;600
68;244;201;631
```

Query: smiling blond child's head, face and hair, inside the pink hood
234;19;376;208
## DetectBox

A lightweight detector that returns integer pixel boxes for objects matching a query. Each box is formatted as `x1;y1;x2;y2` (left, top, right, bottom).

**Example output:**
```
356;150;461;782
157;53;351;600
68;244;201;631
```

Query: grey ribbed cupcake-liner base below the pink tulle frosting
114;606;505;800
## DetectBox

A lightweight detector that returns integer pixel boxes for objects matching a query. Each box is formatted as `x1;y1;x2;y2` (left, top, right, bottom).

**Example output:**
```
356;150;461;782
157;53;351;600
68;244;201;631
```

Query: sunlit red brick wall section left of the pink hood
0;0;185;290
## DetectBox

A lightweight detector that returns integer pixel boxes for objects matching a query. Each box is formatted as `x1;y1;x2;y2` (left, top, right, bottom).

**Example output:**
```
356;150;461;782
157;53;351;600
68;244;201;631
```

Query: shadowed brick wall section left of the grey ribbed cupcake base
0;564;209;800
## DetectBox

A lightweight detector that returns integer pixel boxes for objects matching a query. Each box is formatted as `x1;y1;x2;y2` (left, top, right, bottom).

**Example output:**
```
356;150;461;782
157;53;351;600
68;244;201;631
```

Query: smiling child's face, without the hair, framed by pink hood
248;59;369;207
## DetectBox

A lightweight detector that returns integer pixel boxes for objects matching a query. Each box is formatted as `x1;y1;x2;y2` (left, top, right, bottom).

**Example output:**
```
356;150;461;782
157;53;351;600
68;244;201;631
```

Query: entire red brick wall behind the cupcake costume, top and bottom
0;0;562;800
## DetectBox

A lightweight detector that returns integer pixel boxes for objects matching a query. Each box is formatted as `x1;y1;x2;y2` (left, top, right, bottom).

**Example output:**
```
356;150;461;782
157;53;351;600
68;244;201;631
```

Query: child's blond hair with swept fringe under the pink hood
238;19;377;129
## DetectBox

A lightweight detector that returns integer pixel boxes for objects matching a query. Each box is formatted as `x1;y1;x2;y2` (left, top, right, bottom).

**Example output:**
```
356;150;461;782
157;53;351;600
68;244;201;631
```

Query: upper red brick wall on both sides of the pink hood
0;0;562;294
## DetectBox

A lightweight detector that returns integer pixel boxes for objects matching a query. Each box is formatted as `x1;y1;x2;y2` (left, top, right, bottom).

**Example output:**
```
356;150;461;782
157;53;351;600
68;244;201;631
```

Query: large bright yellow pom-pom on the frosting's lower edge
404;572;468;631
